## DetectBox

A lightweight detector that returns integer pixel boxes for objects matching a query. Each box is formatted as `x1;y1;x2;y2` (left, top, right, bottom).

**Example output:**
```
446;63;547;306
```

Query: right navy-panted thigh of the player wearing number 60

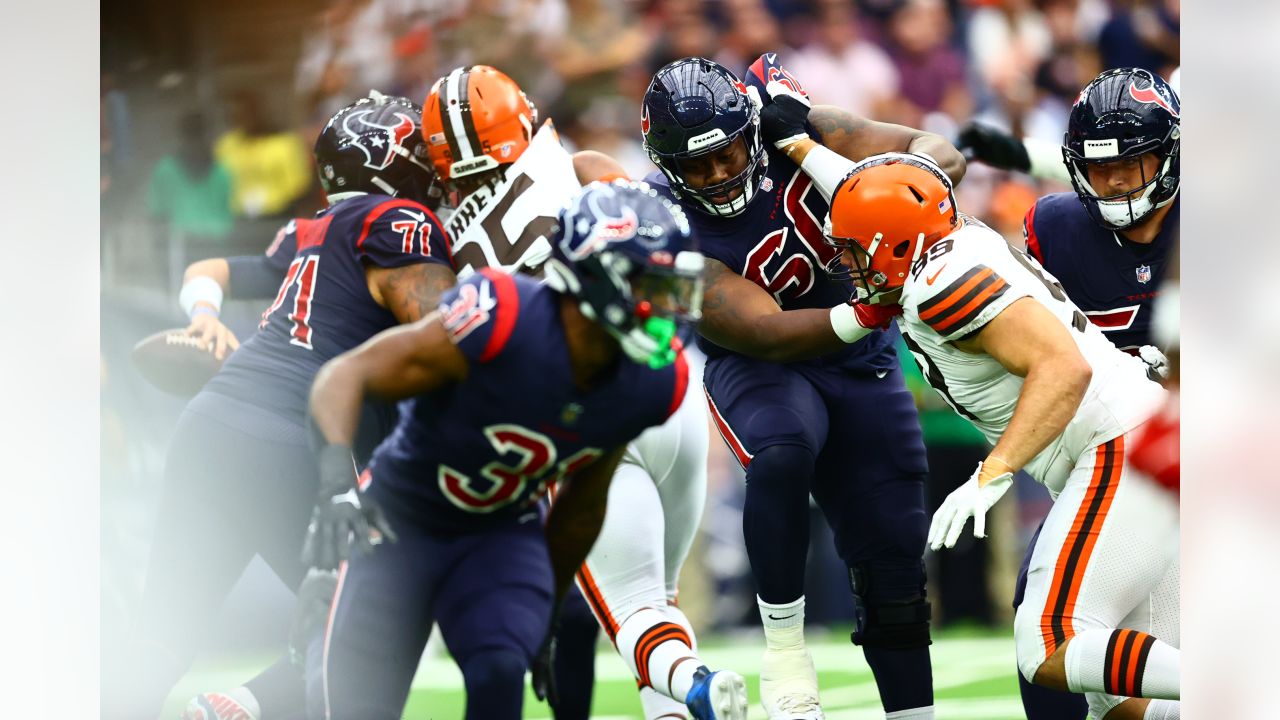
813;370;928;564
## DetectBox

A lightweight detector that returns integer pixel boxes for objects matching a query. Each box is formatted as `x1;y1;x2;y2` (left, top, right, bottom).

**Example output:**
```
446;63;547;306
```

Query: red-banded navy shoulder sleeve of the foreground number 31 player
439;268;521;363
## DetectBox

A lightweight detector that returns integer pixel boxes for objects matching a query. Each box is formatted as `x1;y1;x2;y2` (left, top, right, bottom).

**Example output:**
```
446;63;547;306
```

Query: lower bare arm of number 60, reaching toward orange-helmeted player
698;258;845;363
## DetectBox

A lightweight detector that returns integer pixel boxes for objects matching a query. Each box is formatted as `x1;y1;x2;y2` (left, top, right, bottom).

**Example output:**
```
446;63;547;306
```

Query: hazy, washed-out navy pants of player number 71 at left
102;392;317;720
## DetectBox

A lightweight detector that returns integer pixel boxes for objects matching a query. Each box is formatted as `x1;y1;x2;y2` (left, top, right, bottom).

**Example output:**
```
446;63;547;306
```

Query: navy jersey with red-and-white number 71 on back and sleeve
205;195;451;445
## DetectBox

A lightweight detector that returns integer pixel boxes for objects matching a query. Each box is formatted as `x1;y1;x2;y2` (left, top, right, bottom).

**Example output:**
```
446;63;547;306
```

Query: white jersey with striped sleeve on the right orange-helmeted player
900;217;1165;497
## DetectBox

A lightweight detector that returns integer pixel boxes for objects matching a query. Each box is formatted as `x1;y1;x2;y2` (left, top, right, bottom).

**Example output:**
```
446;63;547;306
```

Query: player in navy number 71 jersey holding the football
102;92;453;720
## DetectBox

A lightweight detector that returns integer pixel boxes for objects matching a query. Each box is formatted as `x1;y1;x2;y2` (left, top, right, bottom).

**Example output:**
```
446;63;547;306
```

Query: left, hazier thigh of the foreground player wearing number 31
307;506;440;720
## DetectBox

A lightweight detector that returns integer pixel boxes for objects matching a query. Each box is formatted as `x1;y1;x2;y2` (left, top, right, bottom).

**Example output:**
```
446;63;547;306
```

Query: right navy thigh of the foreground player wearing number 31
435;520;554;665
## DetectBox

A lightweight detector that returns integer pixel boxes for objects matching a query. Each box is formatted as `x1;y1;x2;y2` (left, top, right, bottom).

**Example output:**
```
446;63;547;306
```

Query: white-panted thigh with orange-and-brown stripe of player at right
1014;437;1178;676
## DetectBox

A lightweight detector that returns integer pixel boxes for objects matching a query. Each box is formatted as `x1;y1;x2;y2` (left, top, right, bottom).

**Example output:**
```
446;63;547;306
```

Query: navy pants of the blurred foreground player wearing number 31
307;477;553;720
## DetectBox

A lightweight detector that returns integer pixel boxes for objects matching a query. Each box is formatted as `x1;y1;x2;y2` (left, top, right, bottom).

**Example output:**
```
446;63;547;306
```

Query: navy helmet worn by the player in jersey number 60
640;58;768;217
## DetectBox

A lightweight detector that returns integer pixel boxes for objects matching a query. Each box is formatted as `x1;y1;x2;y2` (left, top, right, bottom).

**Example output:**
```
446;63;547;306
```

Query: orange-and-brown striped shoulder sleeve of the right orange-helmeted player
911;258;1027;341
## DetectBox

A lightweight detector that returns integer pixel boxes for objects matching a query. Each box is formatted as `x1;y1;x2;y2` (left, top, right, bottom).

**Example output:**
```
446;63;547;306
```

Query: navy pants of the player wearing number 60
704;355;933;712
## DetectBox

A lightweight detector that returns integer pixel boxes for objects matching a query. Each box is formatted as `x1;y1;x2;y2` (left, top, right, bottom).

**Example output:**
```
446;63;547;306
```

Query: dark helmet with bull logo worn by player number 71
315;90;443;210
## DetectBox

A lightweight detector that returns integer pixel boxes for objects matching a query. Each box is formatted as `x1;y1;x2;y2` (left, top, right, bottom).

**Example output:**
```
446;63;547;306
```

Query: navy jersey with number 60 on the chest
645;147;897;370
